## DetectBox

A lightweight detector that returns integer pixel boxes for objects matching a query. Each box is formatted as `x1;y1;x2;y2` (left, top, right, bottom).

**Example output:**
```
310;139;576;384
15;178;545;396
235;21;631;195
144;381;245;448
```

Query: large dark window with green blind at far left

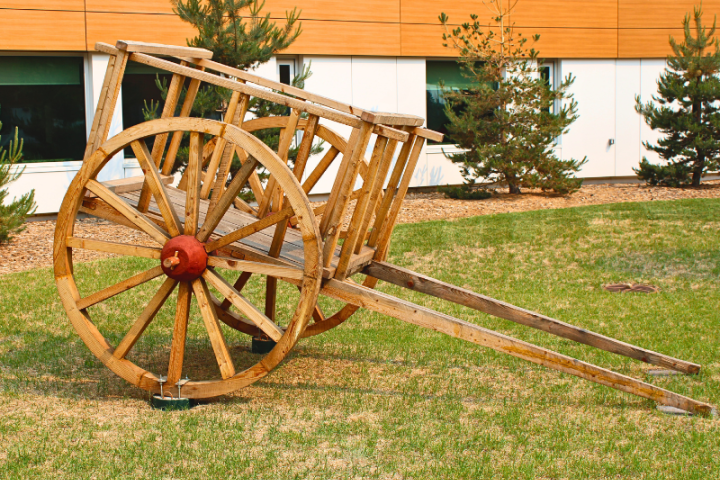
0;57;86;162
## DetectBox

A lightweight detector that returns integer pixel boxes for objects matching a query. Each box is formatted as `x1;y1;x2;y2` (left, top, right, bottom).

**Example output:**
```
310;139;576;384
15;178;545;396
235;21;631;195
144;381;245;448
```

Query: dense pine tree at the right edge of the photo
634;7;720;187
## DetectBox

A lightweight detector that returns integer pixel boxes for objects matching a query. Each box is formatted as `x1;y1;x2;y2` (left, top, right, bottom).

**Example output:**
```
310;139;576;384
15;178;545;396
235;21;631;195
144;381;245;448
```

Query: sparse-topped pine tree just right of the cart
440;0;587;193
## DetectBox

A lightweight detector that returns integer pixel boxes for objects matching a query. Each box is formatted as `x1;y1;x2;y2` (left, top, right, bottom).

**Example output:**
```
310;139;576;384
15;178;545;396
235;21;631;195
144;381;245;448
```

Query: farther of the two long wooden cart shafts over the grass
363;262;700;373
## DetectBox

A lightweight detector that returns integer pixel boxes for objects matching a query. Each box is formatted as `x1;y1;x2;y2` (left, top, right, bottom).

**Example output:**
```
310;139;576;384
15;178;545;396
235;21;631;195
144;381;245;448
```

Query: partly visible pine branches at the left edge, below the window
0;107;37;243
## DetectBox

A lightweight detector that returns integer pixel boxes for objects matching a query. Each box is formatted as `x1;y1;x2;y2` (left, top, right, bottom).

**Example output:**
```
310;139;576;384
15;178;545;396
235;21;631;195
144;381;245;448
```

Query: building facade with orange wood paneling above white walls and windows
0;0;720;213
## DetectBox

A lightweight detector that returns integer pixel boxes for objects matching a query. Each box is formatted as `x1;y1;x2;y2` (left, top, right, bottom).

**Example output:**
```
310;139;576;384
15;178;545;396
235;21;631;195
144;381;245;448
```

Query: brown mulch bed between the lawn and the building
0;180;720;275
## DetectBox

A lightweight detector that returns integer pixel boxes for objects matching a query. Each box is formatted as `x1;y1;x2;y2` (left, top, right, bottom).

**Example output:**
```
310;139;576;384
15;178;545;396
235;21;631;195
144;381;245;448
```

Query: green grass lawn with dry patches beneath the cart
0;200;720;480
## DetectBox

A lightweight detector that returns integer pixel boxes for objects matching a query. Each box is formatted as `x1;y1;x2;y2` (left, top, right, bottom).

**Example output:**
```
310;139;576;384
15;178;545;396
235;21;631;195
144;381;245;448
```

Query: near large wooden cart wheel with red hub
54;118;322;398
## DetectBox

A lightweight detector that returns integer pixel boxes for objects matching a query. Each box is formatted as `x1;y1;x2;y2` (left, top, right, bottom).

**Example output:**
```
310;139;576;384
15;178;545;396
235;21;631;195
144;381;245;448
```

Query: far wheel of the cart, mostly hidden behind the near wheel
220;116;387;338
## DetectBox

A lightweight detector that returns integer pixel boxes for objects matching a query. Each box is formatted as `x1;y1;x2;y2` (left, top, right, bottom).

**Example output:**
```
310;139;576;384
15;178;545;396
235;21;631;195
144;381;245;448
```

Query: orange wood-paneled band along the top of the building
0;0;720;58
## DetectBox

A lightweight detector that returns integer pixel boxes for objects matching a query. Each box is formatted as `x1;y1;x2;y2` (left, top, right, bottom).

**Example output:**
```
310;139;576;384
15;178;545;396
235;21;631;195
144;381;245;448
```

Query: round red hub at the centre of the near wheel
160;235;208;282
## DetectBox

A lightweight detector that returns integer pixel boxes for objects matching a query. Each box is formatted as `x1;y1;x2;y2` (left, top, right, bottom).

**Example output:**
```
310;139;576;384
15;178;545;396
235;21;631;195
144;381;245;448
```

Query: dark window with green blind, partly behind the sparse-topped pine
425;60;470;143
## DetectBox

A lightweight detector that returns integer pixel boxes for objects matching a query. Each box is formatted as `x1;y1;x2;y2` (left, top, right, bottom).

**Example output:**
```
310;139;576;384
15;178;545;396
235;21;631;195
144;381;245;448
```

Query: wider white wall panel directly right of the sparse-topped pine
560;60;615;177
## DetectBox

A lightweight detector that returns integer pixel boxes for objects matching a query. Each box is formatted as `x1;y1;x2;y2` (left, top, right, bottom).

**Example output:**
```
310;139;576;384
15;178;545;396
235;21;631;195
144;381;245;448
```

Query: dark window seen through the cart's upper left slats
122;62;172;158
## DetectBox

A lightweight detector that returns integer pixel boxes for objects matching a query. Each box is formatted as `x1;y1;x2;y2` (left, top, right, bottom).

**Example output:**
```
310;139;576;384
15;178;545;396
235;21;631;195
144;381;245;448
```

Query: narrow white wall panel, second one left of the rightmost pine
613;60;642;176
